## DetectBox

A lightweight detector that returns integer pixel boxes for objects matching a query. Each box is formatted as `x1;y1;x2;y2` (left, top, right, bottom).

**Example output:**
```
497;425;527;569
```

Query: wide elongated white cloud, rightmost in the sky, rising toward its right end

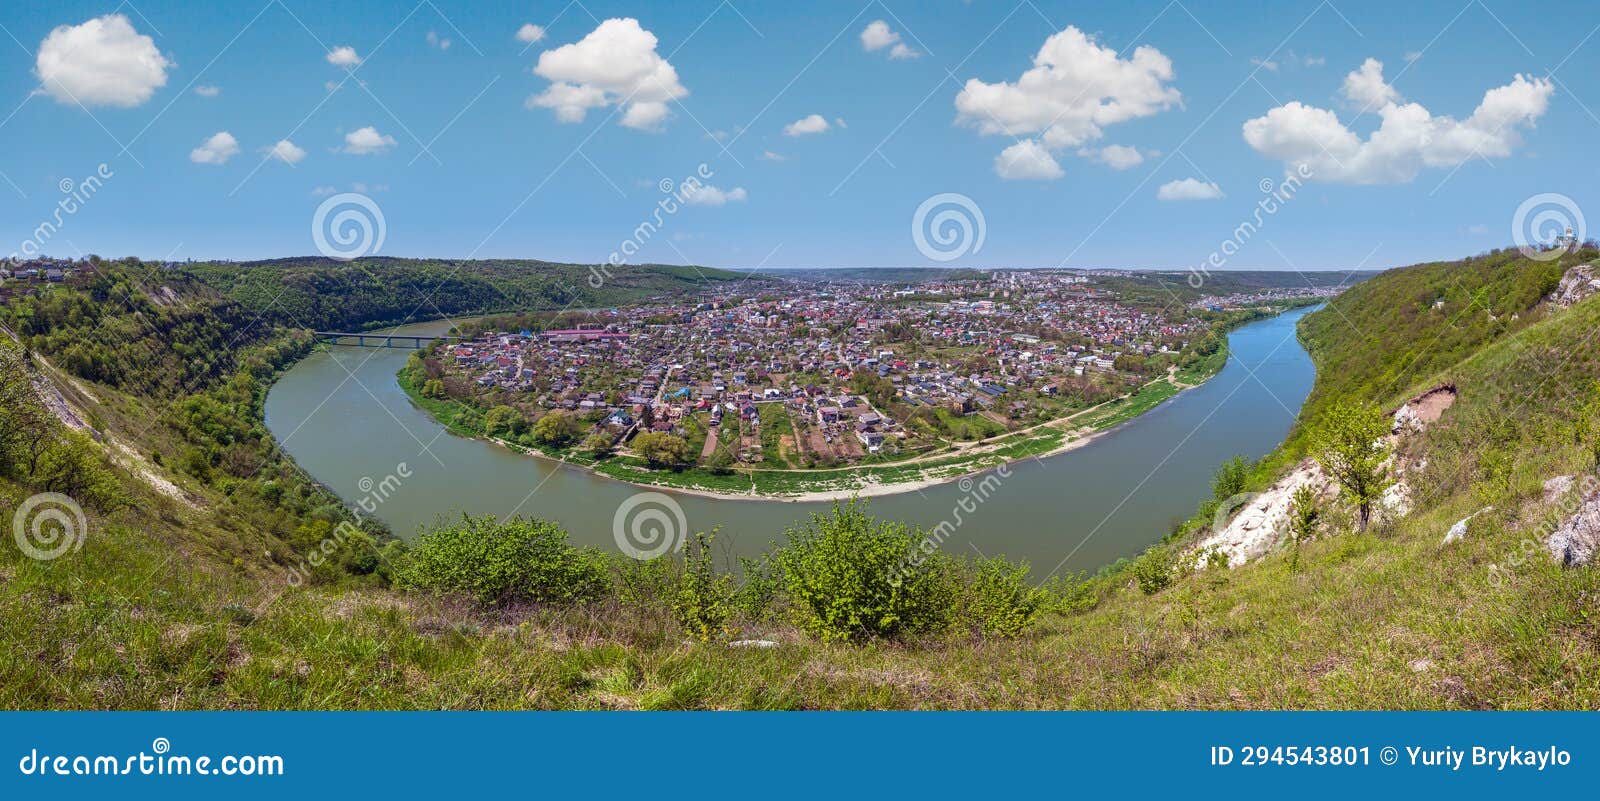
1243;61;1554;184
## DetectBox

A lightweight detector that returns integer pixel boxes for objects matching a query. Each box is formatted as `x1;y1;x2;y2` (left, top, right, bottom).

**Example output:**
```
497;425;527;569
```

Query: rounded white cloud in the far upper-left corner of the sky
34;14;173;109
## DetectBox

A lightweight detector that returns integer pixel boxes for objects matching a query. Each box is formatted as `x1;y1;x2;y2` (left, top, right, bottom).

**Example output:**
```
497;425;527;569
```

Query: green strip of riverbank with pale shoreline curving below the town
387;304;1273;504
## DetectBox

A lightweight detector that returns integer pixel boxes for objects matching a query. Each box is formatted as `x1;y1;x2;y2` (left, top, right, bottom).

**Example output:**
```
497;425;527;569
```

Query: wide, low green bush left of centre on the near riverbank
395;515;610;604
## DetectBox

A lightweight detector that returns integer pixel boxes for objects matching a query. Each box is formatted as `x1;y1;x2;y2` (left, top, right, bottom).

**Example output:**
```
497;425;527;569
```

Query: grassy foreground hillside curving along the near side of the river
0;253;1600;708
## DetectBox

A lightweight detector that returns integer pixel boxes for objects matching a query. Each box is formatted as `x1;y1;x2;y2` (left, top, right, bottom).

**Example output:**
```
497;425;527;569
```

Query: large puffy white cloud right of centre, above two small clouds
955;27;1182;171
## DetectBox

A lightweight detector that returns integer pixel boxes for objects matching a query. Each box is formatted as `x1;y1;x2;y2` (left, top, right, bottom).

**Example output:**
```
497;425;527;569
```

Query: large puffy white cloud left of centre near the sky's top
526;18;690;130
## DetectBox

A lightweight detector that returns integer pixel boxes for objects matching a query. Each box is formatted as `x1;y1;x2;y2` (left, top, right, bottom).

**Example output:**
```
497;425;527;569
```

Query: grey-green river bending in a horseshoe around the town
267;309;1315;579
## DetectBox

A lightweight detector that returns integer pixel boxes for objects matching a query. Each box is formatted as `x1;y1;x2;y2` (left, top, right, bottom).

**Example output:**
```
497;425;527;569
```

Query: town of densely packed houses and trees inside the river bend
406;270;1318;470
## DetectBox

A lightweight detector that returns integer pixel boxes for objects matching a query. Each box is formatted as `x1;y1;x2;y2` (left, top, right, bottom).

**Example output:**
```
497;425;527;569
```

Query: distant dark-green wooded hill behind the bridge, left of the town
184;257;770;331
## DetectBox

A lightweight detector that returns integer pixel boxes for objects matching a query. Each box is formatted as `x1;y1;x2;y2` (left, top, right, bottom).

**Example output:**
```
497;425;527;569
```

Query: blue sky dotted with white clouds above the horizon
0;0;1600;270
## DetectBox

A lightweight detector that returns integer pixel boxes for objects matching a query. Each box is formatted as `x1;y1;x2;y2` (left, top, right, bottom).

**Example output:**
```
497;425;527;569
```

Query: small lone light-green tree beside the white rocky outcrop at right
1314;401;1394;531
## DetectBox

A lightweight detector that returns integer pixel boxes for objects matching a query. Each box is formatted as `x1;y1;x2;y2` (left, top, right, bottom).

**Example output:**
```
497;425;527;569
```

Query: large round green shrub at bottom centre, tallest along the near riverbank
774;502;955;643
